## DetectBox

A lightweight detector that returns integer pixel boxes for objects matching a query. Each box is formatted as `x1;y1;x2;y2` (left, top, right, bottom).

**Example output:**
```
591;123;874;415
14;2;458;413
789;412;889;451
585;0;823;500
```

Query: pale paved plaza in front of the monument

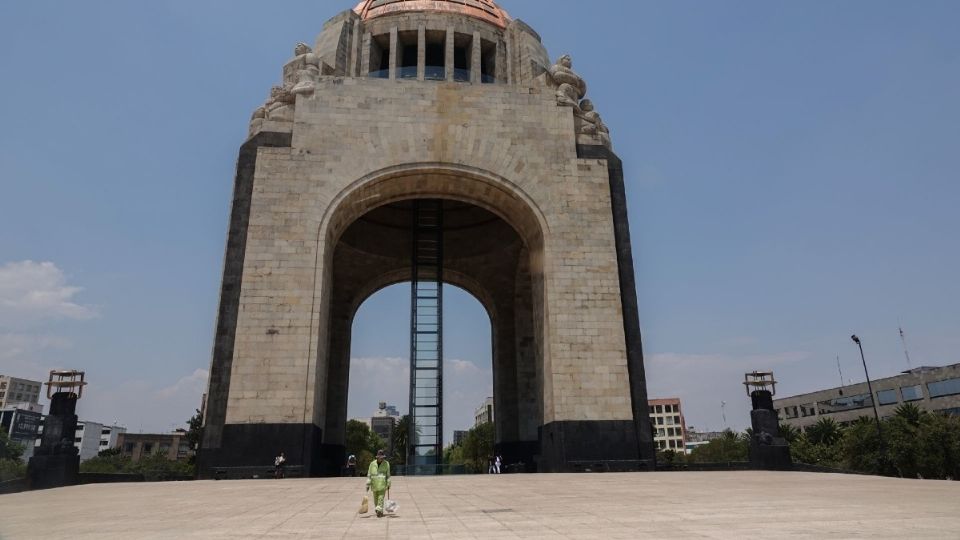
0;472;960;540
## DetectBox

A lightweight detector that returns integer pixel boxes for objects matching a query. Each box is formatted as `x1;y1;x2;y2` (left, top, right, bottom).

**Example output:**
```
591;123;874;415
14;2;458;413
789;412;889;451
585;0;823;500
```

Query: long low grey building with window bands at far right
773;364;960;429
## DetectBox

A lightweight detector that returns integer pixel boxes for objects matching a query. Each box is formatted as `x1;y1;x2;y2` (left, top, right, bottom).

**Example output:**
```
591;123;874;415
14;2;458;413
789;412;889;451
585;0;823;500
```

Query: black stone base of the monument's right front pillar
537;420;654;473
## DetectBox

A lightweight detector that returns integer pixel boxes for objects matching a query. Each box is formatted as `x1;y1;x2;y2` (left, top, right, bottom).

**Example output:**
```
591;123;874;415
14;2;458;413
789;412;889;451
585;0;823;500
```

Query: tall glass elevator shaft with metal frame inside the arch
407;199;443;474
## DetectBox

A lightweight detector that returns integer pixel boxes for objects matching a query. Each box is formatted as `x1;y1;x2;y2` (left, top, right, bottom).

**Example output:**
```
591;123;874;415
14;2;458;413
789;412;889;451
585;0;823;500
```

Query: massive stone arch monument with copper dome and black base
199;0;654;477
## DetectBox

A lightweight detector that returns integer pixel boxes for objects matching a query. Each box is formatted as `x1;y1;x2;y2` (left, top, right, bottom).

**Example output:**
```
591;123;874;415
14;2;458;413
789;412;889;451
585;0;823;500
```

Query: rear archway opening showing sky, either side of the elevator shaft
346;282;493;471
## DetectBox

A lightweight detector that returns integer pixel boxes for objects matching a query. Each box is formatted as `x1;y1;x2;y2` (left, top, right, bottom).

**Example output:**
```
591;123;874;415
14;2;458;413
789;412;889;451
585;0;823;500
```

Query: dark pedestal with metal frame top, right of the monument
743;371;793;470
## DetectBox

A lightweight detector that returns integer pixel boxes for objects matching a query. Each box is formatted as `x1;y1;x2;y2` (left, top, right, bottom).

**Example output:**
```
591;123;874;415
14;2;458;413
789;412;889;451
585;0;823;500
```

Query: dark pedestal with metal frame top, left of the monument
27;371;87;489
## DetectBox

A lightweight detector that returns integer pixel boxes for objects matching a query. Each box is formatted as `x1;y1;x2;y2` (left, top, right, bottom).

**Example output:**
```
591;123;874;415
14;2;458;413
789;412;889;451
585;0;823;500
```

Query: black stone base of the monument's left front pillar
197;424;322;479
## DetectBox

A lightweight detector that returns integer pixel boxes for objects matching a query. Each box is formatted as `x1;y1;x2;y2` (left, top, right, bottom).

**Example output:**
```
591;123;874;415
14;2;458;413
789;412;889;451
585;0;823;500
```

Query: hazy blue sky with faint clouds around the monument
0;0;960;438
